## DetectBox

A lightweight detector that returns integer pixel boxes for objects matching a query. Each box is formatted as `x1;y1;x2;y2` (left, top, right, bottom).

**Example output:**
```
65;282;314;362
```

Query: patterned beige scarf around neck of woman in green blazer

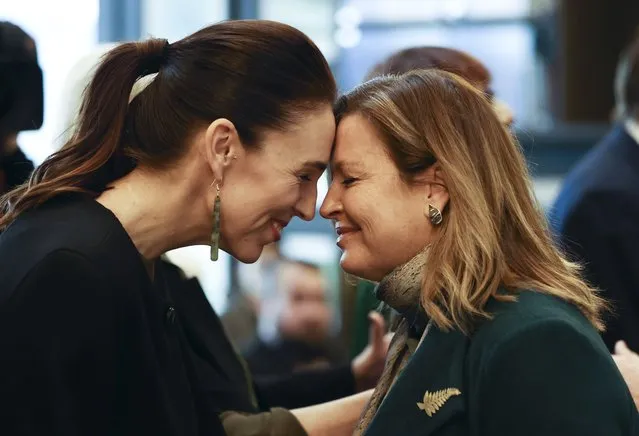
353;247;428;436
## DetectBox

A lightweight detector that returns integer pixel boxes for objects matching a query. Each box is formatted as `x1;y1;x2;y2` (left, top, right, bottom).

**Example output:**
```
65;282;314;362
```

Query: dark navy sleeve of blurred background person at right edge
561;194;639;351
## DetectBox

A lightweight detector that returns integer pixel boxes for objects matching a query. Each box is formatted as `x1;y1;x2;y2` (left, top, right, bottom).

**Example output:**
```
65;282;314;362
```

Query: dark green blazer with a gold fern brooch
366;292;639;436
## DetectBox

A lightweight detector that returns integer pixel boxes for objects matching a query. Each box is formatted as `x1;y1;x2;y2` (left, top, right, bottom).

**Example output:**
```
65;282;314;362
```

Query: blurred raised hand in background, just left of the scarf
351;312;393;392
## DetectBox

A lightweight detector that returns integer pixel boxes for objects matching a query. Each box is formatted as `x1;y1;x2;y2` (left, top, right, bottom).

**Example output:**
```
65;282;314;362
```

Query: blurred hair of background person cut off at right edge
615;31;639;119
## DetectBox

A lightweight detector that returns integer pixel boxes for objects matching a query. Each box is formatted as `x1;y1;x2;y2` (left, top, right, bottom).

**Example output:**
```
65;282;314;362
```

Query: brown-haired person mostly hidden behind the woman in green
351;46;514;355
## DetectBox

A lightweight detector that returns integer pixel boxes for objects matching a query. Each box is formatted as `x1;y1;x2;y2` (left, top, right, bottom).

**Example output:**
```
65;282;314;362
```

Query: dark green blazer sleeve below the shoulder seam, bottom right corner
473;320;637;436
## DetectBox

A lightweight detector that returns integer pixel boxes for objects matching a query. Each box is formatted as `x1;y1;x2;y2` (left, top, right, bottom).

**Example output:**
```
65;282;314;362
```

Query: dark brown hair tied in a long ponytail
0;20;336;229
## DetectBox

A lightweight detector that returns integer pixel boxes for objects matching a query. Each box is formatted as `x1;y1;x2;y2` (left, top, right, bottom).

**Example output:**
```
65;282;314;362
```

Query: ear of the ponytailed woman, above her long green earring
204;118;243;183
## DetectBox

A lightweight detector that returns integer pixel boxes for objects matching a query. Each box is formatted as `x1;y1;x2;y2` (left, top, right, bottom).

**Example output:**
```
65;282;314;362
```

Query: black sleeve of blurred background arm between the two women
255;364;355;409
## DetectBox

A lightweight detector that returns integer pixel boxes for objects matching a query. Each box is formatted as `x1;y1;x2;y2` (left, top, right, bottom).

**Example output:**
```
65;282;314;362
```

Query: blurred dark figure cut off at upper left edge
0;21;44;194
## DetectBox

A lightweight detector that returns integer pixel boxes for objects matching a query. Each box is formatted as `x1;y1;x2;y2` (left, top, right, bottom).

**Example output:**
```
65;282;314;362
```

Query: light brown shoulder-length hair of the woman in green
336;70;604;332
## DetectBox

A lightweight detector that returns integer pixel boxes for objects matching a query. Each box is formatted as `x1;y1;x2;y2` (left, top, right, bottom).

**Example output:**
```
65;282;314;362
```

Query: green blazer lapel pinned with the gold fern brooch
366;327;468;436
